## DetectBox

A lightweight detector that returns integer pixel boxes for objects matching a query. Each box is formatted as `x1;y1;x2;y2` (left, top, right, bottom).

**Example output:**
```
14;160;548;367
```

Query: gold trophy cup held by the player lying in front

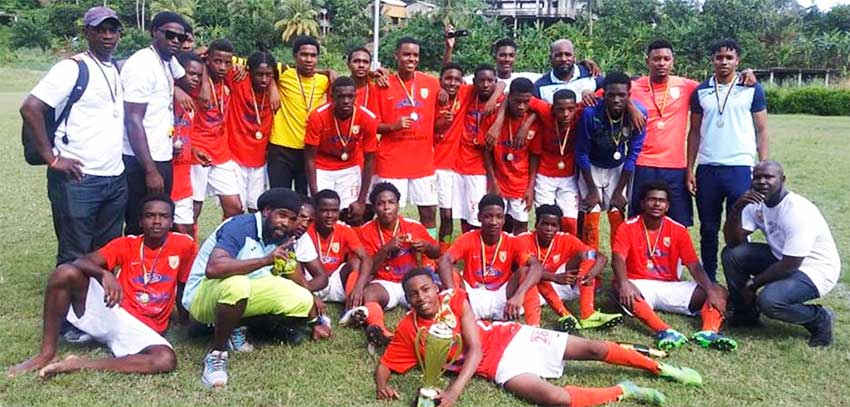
415;322;463;407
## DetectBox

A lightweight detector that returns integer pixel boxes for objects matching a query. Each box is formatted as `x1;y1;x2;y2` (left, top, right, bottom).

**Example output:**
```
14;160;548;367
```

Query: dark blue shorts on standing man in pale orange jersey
629;165;694;226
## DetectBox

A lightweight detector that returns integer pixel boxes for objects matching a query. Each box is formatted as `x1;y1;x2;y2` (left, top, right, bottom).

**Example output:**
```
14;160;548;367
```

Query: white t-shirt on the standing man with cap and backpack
30;54;124;176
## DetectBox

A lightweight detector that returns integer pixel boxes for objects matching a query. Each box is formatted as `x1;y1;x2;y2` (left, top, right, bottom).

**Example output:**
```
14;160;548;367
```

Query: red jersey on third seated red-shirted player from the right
449;230;531;290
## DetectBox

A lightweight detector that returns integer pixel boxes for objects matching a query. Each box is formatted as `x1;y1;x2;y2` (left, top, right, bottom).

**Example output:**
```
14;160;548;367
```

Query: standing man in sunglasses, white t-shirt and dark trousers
121;11;188;235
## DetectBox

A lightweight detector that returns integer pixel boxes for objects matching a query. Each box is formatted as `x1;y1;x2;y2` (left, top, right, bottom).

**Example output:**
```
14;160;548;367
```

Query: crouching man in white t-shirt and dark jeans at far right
721;160;841;347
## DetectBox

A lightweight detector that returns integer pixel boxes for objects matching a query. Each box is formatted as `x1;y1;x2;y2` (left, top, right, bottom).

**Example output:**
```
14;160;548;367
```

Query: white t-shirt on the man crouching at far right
741;192;841;297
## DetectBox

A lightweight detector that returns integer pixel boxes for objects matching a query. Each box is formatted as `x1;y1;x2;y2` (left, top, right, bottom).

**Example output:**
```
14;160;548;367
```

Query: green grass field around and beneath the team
0;69;850;407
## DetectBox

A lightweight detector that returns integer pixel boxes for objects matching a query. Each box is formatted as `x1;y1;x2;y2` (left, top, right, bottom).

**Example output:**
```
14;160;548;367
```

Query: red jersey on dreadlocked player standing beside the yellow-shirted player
224;77;274;168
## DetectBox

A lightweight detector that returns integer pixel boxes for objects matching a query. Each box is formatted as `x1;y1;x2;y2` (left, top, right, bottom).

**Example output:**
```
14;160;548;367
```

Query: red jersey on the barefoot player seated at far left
98;232;196;333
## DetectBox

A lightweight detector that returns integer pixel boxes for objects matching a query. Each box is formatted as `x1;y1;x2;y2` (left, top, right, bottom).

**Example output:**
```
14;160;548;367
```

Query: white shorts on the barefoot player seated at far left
65;278;173;358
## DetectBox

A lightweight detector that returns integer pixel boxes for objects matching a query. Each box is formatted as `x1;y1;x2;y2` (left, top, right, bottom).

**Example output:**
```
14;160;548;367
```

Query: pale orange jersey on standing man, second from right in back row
630;76;699;168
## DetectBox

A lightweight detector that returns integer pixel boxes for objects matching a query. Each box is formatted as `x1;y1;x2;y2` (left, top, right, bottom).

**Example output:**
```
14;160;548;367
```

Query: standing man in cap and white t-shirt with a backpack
21;7;127;264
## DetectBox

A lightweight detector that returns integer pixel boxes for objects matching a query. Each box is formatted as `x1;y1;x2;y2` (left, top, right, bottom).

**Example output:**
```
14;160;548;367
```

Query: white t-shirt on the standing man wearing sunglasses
121;47;186;162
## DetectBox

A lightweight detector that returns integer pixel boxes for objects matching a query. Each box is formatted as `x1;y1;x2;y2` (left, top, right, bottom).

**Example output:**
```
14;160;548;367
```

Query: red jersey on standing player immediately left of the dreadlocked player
190;74;233;165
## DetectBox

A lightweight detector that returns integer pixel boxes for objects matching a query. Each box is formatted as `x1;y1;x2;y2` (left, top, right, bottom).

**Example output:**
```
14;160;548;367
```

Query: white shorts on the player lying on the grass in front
494;325;570;386
